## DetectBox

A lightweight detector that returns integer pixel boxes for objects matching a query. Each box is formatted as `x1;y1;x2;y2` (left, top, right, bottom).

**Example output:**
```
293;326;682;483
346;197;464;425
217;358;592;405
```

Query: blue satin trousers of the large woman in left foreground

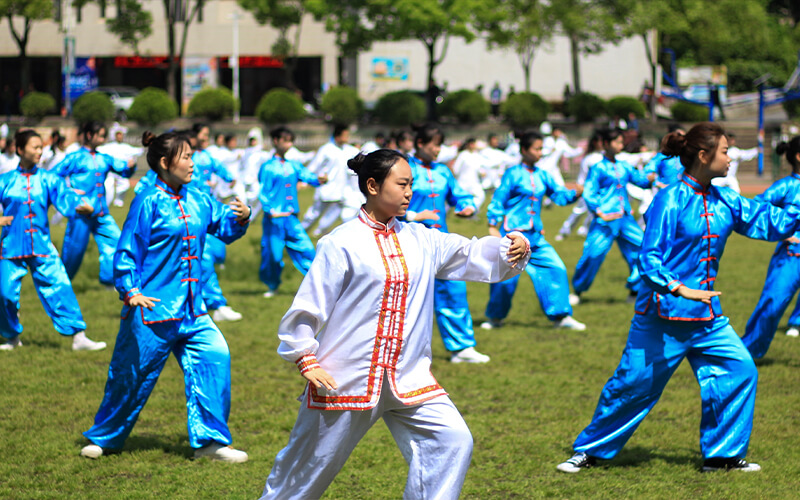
83;308;232;449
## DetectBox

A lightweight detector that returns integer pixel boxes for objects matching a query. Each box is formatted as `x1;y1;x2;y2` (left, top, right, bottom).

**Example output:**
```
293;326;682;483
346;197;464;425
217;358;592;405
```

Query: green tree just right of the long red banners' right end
238;0;305;87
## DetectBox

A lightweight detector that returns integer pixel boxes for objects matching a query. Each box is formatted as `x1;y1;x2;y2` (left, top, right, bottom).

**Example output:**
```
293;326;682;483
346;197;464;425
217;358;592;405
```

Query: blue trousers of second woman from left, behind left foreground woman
61;214;120;286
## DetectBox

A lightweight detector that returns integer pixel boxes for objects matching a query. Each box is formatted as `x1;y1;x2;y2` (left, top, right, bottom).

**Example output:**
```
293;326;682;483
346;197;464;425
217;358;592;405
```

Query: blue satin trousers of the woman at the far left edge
0;253;86;338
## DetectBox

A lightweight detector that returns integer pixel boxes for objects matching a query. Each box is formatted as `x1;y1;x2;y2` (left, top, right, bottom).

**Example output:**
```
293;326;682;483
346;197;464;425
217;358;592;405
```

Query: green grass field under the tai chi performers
0;188;800;500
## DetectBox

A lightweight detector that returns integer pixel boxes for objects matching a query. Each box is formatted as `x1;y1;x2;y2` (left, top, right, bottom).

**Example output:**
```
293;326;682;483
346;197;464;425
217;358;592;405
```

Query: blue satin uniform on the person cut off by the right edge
742;174;800;358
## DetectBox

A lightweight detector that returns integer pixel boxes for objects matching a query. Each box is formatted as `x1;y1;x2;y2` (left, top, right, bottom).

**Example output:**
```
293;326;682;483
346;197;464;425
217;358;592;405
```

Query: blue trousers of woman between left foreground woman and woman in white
258;213;316;290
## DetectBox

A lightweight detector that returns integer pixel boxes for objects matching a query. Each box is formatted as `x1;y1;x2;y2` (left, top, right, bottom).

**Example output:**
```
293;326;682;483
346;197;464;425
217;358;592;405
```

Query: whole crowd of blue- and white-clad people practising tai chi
0;116;800;498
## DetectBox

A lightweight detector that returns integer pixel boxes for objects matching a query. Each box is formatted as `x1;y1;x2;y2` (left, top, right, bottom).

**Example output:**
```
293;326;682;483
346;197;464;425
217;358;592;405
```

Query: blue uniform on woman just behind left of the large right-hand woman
572;157;650;294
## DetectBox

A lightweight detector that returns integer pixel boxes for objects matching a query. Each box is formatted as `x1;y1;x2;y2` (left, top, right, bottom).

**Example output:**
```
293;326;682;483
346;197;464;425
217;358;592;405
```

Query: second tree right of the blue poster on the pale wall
480;0;554;92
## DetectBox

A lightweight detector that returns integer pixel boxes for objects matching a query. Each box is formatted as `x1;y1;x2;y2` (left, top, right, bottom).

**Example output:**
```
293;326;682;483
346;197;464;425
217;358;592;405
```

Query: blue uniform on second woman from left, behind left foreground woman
55;147;136;286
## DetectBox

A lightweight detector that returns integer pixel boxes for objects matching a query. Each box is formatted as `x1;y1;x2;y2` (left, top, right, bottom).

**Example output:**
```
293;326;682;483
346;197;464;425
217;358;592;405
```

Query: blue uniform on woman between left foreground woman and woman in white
258;155;320;291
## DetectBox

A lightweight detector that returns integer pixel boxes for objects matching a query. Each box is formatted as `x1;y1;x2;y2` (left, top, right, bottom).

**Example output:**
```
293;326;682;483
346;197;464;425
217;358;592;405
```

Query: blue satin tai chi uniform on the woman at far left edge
0;166;86;339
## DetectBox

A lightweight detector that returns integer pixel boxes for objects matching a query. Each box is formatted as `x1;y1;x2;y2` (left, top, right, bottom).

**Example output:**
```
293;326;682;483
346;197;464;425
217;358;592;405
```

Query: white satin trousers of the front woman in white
261;377;472;500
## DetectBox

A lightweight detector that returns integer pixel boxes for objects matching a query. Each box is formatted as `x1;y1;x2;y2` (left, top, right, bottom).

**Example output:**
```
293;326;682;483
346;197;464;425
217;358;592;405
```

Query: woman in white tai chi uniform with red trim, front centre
262;149;530;499
